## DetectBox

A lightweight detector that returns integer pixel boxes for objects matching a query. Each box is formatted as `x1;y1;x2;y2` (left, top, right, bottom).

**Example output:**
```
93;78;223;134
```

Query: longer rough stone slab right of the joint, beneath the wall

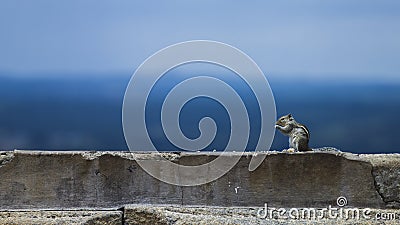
124;205;400;225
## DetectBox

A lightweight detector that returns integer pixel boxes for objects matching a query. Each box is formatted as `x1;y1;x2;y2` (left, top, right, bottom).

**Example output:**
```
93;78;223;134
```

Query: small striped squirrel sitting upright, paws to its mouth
275;114;312;152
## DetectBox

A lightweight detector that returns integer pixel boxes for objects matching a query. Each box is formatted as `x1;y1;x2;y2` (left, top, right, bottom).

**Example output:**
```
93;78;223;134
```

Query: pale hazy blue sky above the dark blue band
0;0;400;81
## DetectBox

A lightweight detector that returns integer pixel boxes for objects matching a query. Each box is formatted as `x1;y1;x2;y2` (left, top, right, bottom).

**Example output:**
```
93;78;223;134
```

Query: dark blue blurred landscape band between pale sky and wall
0;74;400;153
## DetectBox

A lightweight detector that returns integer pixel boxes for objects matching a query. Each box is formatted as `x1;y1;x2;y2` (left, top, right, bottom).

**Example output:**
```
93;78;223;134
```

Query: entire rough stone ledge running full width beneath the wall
0;205;400;225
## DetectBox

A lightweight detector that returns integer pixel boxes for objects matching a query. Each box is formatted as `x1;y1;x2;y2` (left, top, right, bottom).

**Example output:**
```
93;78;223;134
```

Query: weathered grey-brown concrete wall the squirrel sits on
0;149;400;210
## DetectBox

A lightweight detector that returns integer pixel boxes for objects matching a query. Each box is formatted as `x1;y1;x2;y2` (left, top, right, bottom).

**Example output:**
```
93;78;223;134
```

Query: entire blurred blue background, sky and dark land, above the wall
0;0;400;153
